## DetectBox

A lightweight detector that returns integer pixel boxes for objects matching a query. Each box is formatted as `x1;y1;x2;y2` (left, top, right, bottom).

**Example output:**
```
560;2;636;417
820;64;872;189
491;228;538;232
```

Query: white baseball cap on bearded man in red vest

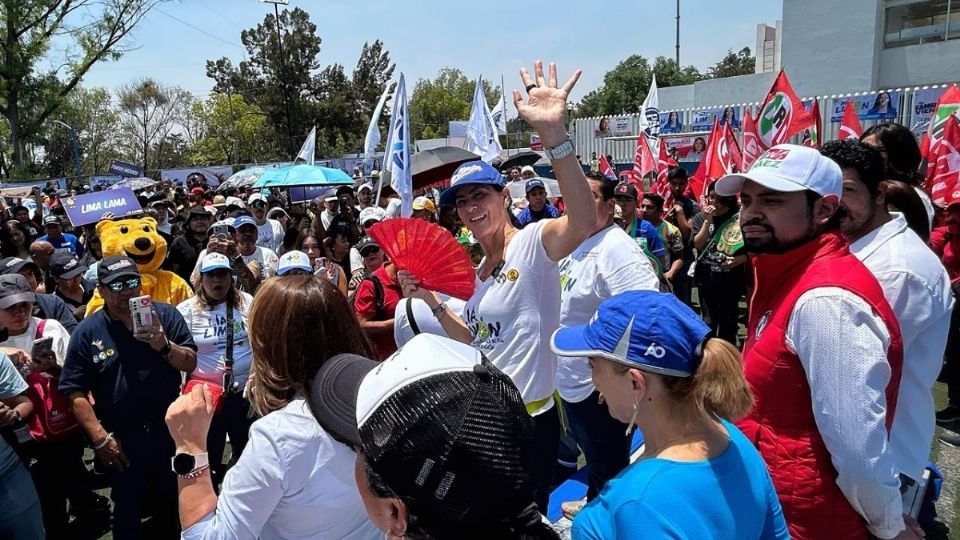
715;144;843;199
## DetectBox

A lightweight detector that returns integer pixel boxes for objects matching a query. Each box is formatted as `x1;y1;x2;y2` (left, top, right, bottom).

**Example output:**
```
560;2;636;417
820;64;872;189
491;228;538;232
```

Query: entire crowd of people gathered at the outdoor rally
0;62;960;540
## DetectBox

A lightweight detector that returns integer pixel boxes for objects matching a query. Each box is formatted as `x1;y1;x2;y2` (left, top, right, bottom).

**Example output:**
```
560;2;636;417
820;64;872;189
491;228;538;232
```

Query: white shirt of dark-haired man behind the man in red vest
850;214;953;480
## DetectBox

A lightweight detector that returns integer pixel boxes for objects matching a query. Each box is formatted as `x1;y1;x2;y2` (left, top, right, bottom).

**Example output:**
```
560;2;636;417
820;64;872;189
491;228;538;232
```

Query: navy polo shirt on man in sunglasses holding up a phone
60;302;197;432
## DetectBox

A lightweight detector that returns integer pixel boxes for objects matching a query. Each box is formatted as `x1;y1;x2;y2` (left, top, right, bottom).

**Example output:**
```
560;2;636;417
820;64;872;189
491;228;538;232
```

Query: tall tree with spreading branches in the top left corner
0;0;163;174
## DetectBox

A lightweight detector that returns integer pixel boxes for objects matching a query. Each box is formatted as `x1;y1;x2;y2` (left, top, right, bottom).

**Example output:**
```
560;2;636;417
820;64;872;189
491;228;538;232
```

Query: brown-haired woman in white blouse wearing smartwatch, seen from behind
167;276;382;540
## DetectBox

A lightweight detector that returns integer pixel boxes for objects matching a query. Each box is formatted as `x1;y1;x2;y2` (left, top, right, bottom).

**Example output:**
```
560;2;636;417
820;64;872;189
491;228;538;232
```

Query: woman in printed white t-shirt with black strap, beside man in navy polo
177;252;253;485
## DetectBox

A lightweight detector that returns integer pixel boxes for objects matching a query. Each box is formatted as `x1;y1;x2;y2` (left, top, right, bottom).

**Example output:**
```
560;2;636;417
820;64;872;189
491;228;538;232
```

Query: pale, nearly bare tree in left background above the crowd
117;79;192;169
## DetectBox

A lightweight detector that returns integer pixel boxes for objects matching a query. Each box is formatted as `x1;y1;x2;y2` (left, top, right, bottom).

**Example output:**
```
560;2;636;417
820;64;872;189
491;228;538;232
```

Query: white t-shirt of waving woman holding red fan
463;221;560;412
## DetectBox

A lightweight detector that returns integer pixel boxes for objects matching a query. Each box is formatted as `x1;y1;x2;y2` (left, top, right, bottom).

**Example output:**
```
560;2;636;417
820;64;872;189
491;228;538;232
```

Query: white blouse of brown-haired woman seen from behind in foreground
183;398;383;540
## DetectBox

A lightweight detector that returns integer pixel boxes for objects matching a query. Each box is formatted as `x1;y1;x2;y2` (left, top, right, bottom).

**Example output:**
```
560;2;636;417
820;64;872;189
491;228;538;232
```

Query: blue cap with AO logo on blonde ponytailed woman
550;291;710;377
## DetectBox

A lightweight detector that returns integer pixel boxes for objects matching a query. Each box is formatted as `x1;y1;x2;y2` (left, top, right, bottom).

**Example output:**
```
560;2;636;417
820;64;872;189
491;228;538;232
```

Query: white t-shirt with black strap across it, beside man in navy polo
177;292;253;388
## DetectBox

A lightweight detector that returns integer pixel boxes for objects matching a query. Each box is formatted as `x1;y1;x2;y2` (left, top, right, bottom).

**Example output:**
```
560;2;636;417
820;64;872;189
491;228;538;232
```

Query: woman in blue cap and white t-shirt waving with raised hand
398;61;596;509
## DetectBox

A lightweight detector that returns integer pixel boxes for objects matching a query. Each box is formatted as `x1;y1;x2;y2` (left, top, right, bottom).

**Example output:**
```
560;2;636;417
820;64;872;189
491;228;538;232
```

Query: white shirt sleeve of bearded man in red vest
786;287;904;538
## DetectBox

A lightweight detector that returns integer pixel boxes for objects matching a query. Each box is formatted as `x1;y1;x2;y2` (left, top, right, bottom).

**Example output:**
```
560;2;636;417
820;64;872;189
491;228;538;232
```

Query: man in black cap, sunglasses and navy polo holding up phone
60;256;197;540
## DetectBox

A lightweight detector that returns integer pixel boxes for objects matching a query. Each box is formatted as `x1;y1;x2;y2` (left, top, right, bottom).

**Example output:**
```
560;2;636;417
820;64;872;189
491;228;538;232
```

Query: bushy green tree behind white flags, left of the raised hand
409;67;500;140
